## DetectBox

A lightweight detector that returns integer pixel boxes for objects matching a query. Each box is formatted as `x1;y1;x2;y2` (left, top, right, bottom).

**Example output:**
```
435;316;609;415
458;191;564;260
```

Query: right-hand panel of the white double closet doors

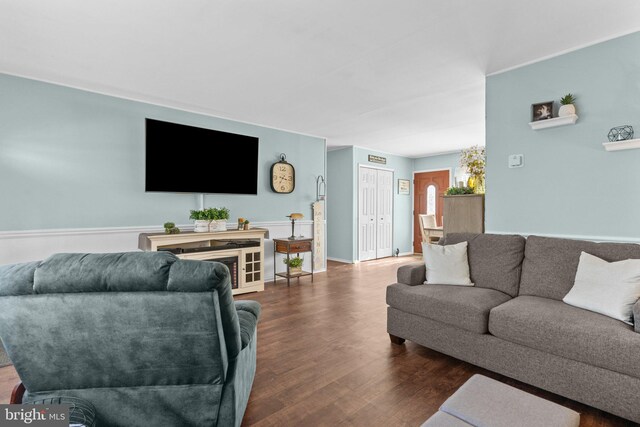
376;170;393;258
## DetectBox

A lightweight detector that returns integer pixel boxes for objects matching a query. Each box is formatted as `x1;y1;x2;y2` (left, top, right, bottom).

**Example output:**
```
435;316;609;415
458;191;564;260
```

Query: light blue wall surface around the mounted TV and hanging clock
0;74;325;231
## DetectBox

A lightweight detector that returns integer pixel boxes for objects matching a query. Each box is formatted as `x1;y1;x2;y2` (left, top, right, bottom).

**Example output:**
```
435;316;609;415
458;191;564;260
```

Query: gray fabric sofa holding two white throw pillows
387;234;640;422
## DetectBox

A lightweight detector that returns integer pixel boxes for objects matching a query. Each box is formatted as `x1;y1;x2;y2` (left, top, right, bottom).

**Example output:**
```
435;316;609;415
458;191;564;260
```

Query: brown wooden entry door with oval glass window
413;170;451;253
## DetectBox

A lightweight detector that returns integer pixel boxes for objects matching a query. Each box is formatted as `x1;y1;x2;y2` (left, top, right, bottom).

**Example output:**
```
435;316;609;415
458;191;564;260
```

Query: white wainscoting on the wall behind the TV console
0;221;326;282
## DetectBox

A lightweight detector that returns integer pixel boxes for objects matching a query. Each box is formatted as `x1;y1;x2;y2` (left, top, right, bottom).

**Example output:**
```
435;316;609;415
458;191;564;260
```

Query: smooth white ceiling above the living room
0;0;640;157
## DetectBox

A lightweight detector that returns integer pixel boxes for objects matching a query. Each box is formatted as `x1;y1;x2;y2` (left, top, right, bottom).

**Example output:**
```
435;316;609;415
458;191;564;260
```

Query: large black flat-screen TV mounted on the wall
145;119;258;194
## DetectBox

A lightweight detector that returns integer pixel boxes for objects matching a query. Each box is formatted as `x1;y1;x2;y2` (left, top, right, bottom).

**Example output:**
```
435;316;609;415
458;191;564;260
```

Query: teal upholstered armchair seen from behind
0;252;260;426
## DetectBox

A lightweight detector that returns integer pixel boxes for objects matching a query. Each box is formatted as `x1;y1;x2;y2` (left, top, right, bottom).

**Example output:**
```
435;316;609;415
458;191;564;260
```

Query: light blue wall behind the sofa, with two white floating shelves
486;33;640;240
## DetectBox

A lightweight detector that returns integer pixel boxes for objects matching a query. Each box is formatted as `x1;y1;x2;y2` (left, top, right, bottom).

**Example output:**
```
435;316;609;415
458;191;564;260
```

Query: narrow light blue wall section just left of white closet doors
326;147;357;262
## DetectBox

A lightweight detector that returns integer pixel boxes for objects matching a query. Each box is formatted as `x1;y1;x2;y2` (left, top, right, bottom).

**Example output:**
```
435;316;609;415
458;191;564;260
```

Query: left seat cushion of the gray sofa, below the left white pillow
387;283;511;334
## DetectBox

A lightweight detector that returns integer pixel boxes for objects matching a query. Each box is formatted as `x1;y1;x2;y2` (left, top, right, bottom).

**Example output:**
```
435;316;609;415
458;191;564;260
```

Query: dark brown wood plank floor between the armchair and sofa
0;258;633;427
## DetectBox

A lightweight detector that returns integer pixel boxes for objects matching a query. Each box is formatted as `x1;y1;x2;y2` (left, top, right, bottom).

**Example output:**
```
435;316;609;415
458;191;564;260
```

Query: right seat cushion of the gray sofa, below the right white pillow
489;296;640;378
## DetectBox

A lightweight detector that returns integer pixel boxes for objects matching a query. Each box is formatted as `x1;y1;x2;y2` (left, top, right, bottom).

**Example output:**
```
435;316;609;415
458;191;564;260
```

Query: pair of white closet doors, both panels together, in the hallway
358;166;393;261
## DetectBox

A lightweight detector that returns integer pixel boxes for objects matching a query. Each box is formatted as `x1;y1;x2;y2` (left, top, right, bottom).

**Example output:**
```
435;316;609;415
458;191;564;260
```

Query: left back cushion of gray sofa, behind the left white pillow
444;233;526;297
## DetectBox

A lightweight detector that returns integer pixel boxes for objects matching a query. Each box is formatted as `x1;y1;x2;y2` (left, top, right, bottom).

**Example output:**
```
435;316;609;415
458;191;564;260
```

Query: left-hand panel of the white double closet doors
358;168;378;261
